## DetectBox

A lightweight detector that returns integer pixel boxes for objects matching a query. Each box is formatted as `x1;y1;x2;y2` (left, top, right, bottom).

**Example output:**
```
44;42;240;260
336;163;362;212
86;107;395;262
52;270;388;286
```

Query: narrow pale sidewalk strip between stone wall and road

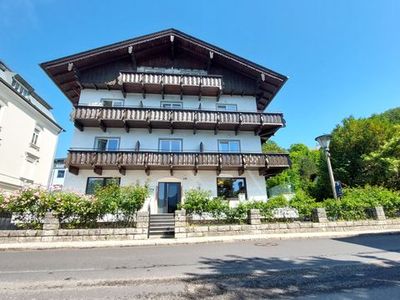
0;229;400;251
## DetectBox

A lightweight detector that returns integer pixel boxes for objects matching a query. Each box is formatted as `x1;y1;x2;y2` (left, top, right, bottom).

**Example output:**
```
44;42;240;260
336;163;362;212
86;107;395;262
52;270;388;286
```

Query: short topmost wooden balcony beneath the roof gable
118;71;223;98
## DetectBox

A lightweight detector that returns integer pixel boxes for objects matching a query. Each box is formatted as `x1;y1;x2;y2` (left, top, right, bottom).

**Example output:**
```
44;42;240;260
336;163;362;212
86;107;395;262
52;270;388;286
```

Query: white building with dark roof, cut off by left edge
0;61;62;191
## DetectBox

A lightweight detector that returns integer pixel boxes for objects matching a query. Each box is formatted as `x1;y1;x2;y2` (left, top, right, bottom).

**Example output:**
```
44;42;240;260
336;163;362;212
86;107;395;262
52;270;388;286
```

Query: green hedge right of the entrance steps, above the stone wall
181;186;400;223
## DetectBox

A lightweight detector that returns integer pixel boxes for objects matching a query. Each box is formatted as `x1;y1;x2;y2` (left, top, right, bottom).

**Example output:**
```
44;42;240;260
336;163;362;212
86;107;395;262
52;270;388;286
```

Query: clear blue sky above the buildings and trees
0;0;400;157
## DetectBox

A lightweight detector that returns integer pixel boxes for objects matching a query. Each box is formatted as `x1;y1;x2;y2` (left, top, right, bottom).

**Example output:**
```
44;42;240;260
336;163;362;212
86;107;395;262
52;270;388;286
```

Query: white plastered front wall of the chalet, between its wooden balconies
64;89;267;213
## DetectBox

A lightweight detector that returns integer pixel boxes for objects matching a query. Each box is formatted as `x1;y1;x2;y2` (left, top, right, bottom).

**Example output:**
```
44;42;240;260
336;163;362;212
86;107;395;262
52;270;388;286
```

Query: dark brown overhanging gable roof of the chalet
40;29;287;109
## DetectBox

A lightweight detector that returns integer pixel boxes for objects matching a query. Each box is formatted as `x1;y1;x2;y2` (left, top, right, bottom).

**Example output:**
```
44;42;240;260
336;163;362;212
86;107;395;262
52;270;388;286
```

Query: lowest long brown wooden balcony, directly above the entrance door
66;150;290;176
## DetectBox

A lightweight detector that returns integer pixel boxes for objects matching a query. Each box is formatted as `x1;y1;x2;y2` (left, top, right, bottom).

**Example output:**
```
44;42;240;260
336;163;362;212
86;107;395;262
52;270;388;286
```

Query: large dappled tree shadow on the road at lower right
183;246;400;299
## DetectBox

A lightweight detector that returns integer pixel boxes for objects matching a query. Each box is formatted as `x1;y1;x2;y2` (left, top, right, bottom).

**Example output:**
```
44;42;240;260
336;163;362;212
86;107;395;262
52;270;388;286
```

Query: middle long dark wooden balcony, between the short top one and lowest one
72;106;285;138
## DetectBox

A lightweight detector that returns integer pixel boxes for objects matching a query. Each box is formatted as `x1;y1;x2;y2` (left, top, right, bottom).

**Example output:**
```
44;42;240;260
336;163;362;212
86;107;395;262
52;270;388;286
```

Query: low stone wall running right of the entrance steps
179;219;400;238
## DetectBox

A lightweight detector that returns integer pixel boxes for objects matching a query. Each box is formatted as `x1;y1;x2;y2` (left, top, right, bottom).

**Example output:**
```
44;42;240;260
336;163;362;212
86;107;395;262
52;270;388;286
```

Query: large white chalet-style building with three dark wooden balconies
41;29;289;213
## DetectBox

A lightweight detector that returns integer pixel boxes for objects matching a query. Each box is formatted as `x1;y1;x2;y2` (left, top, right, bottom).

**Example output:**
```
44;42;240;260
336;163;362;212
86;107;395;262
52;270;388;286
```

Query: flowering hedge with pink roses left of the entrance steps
0;185;149;228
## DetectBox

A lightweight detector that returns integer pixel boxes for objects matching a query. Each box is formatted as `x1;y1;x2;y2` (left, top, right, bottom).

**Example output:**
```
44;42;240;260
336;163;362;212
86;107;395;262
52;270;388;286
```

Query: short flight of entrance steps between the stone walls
149;214;175;238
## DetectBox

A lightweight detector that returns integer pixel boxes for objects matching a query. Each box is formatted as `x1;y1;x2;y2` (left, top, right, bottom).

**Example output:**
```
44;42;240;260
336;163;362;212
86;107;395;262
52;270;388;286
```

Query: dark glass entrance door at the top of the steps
158;182;181;213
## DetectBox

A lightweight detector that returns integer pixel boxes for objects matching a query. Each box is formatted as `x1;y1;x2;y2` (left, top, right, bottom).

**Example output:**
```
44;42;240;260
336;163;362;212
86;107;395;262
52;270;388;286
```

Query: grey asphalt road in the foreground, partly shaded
0;235;400;299
